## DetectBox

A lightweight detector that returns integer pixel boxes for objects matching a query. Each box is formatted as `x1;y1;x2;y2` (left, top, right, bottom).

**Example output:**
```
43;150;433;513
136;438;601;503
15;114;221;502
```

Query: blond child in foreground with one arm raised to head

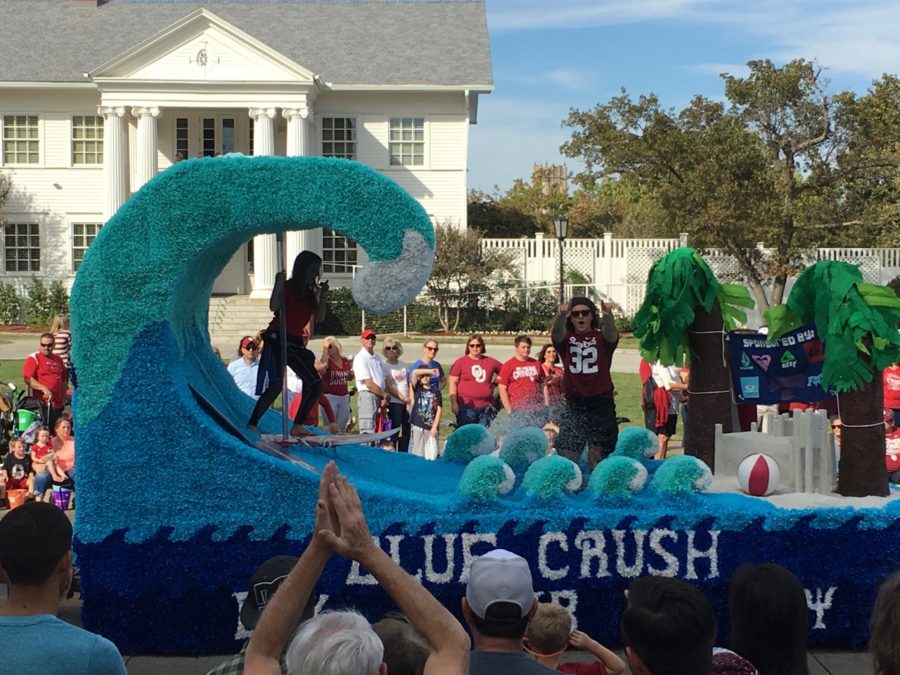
525;602;625;675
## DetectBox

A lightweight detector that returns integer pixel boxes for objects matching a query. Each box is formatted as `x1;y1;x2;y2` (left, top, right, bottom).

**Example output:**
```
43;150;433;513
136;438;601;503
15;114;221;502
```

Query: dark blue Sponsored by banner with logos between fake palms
726;324;833;405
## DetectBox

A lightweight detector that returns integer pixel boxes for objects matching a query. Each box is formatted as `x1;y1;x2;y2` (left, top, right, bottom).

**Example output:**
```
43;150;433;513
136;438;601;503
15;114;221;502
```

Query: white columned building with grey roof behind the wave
0;0;493;297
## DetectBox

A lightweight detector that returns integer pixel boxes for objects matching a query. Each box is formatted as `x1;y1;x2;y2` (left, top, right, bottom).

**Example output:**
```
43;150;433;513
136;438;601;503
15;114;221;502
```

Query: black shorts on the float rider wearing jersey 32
556;396;619;462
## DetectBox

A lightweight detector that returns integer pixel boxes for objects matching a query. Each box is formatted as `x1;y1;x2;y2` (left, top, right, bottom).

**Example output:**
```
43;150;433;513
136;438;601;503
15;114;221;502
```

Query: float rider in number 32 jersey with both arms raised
551;297;619;469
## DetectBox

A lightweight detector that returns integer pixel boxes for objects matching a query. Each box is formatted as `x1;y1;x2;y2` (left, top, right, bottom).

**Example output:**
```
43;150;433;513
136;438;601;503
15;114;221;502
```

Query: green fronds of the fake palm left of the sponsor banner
634;247;753;365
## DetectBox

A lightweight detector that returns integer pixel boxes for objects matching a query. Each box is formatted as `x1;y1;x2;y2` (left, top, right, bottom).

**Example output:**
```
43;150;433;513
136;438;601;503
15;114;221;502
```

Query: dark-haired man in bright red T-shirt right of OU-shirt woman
497;335;547;427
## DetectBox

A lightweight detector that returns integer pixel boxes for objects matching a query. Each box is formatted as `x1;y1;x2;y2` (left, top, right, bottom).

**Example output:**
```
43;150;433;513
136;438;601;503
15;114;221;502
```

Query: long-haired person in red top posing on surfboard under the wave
247;251;328;436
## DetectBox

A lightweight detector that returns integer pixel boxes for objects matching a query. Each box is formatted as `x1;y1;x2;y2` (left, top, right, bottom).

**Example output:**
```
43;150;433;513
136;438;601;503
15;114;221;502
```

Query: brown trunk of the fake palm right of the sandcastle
838;382;889;497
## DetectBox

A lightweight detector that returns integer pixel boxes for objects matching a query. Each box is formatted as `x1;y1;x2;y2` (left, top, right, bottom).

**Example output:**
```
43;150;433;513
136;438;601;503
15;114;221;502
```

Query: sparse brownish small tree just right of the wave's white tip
425;223;513;332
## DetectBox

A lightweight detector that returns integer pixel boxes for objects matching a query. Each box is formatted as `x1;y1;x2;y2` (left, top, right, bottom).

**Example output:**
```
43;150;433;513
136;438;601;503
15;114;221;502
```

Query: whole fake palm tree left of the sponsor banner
634;247;754;468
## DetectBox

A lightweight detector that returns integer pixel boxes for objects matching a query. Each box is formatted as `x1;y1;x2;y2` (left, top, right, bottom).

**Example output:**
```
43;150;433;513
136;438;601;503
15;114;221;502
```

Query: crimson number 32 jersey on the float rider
557;330;619;398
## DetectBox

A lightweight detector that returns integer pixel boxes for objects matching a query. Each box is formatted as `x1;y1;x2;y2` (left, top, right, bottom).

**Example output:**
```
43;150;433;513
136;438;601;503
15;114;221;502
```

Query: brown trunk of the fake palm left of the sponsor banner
684;303;732;470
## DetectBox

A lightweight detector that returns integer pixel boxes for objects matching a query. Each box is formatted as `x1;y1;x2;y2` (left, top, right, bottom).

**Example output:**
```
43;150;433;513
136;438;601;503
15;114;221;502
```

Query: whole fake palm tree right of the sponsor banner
766;261;900;497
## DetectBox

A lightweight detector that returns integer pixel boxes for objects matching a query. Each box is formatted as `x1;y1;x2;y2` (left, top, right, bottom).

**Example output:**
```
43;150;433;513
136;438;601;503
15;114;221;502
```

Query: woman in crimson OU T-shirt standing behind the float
449;335;500;427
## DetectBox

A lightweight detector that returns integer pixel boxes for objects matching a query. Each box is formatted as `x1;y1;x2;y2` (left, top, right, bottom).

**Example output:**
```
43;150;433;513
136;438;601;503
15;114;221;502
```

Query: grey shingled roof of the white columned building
0;0;493;89
